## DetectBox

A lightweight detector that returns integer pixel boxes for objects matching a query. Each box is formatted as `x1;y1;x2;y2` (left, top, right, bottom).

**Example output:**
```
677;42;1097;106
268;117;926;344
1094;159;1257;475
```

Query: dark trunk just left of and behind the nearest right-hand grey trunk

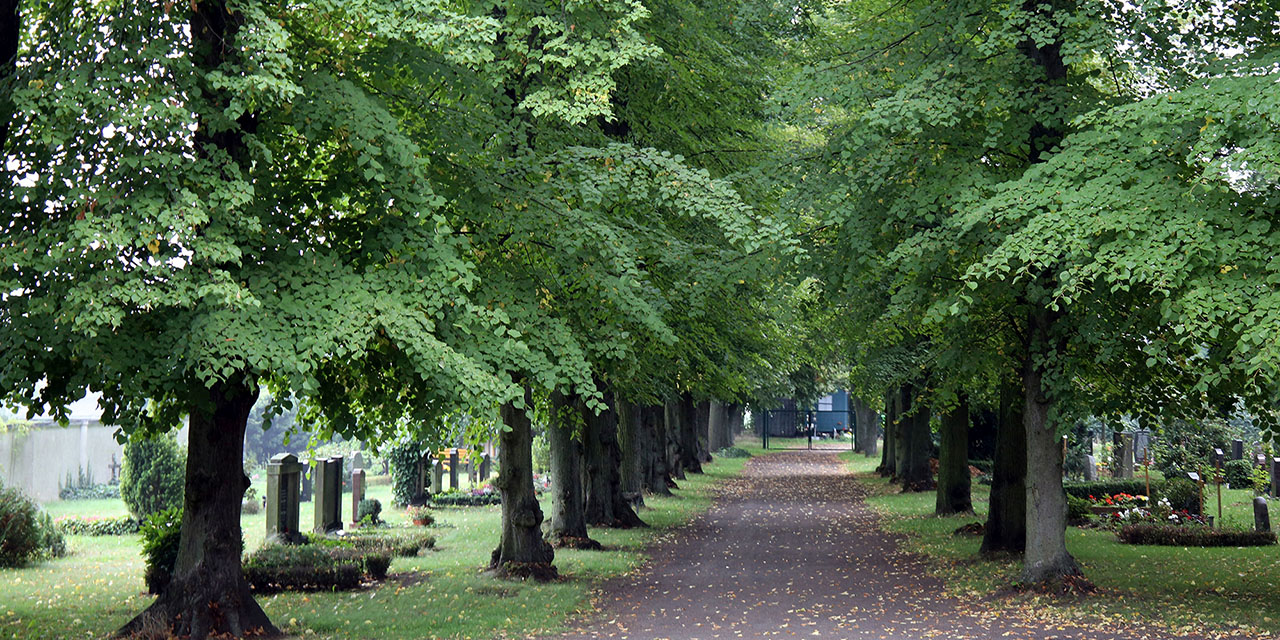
980;381;1027;554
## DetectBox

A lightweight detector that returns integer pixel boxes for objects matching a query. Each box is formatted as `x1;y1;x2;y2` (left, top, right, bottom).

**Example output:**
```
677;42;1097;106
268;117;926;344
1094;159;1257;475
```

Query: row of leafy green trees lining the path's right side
782;0;1280;584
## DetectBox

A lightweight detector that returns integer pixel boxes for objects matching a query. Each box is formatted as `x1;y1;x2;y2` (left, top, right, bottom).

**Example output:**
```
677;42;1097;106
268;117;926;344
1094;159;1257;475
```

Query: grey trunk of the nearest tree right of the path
1021;308;1084;584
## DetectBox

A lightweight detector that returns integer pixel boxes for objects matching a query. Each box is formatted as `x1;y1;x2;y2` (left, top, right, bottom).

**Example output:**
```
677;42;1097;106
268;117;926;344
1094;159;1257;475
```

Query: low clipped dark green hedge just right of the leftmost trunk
243;541;392;591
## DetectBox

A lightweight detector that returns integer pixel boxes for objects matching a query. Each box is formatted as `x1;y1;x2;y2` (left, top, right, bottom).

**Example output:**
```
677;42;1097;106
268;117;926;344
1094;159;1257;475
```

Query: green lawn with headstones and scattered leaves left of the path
0;443;763;640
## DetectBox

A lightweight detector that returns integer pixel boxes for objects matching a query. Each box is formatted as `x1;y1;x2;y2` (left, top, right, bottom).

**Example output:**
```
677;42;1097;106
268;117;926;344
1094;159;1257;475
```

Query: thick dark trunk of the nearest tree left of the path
119;379;279;640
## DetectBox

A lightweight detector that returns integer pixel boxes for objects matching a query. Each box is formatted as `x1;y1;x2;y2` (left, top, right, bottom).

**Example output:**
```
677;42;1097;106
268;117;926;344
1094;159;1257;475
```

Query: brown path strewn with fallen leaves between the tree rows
564;451;1208;640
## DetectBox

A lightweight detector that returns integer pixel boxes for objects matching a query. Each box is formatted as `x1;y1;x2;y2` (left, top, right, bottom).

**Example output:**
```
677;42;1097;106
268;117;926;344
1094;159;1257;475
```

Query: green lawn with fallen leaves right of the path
841;452;1280;637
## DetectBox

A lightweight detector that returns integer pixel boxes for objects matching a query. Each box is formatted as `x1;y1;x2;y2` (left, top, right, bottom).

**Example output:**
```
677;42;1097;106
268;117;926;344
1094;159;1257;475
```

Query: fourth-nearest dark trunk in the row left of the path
582;385;646;529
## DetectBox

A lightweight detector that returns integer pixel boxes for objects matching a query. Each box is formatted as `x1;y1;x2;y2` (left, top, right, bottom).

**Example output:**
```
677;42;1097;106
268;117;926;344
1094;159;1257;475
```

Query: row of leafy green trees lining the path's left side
0;0;813;639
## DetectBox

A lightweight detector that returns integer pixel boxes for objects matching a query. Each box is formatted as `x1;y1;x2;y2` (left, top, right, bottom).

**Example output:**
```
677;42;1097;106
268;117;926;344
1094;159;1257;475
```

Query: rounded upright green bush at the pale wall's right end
120;435;186;520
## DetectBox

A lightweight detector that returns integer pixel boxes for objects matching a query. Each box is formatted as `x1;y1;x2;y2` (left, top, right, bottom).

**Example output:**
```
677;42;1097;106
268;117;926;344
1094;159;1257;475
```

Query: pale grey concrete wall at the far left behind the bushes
0;421;124;502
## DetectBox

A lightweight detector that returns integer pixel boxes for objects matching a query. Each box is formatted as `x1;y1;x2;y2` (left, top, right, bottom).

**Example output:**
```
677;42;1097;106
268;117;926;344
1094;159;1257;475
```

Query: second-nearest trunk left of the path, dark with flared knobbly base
489;387;557;580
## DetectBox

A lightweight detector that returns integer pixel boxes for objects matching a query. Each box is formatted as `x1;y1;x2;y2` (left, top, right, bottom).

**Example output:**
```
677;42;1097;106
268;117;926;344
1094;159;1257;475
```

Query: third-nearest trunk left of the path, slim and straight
547;392;602;549
